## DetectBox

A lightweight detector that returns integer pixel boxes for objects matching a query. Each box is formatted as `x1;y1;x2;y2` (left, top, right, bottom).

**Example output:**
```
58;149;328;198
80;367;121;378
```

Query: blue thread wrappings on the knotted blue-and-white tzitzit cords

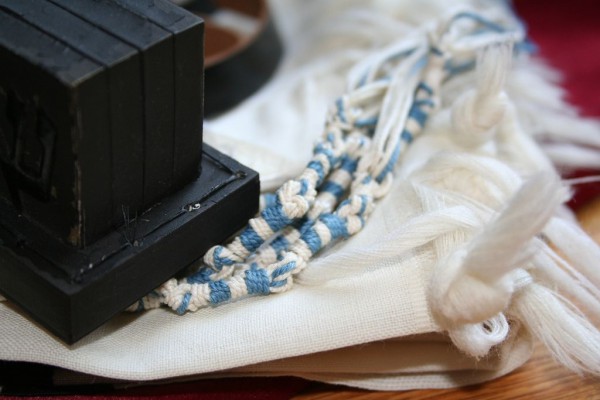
150;13;526;313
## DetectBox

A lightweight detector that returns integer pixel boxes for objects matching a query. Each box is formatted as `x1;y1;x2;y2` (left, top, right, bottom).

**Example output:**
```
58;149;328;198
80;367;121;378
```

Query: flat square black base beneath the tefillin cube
0;145;260;343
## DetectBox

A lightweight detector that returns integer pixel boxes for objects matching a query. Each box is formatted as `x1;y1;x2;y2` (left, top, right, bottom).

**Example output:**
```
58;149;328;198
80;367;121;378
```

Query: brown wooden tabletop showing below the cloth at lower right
294;197;600;400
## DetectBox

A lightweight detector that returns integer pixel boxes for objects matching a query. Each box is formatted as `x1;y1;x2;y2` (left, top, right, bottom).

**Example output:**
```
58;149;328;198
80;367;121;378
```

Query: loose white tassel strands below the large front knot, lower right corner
510;283;600;375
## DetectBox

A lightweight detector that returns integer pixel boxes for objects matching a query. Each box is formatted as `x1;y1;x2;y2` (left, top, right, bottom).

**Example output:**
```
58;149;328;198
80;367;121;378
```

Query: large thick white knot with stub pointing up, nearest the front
429;174;565;327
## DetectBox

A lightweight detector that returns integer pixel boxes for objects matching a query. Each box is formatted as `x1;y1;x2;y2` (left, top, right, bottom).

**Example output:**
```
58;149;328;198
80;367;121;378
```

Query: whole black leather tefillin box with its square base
0;0;259;343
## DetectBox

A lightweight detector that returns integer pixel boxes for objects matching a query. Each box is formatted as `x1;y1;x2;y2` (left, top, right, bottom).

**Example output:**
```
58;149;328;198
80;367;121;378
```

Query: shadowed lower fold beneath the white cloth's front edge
53;329;531;390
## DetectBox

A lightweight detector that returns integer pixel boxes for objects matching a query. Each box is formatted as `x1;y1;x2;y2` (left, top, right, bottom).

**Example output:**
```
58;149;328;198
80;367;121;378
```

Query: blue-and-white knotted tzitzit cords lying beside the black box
129;12;524;314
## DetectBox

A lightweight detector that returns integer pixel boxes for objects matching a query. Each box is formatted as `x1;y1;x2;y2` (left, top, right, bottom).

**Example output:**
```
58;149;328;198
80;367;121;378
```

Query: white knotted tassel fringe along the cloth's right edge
268;0;600;374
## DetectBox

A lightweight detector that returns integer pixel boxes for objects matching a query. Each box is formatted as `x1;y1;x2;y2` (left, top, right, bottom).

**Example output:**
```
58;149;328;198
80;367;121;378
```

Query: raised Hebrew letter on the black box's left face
0;88;56;203
